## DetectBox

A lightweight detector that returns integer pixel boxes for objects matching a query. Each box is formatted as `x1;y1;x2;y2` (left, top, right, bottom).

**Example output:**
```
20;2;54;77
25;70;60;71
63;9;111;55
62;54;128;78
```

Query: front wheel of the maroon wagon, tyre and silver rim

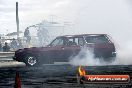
24;55;39;66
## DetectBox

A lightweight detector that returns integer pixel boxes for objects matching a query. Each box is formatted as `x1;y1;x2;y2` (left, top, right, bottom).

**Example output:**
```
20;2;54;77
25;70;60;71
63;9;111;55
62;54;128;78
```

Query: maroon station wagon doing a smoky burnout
13;34;116;66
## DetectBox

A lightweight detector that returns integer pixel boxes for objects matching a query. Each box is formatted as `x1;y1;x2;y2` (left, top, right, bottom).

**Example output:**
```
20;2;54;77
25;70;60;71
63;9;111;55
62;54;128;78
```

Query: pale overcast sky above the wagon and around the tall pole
0;0;132;44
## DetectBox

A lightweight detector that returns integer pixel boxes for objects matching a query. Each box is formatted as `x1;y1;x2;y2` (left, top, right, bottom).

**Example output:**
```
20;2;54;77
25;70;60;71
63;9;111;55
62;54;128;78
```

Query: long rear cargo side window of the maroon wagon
85;35;109;43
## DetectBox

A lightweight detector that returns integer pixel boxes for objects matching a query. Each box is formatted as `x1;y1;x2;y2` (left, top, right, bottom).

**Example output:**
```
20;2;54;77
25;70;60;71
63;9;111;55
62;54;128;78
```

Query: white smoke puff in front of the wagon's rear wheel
69;48;101;66
